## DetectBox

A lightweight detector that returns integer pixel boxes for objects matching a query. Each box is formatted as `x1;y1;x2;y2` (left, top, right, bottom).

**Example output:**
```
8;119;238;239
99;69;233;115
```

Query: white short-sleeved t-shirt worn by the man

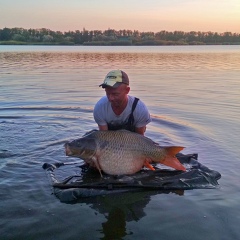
93;95;151;128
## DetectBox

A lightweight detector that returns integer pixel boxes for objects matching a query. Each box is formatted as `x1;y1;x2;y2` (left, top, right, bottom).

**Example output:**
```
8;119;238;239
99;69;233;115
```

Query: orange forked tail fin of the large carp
161;147;186;171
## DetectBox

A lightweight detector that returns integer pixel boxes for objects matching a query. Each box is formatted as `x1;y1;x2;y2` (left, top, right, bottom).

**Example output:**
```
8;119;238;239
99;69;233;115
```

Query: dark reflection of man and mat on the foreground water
86;191;183;240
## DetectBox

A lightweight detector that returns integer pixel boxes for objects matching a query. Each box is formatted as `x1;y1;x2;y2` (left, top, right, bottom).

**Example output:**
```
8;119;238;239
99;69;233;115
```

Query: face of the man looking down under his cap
105;84;130;107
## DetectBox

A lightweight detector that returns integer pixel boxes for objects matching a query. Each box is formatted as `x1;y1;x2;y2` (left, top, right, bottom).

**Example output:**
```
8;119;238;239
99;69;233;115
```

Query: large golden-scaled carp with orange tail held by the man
65;130;186;175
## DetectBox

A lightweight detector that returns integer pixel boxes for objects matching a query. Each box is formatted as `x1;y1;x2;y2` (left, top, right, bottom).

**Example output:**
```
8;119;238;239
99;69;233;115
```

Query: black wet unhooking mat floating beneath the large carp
42;154;221;202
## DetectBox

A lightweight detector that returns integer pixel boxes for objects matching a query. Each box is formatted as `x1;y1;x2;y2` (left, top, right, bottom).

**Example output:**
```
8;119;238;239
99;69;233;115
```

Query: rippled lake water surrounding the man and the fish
0;46;240;240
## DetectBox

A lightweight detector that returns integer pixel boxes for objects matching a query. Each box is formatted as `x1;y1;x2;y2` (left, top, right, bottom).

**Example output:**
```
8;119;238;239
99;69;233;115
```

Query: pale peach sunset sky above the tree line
0;0;240;33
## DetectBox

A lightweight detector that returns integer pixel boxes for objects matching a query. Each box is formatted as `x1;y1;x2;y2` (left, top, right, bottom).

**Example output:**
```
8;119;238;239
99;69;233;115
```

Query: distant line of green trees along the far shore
0;28;240;45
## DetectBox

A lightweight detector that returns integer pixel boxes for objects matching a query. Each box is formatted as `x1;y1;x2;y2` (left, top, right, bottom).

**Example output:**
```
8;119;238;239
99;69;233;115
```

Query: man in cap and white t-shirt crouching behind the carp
93;70;151;135
